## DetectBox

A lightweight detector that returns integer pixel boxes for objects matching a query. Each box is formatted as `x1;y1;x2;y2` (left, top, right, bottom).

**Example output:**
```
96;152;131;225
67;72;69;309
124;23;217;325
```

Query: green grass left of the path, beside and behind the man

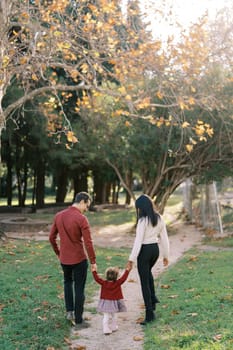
0;241;129;350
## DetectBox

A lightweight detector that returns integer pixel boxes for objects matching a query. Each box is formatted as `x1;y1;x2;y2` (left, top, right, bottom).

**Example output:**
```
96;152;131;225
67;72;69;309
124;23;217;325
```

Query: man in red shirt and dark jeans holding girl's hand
49;192;96;328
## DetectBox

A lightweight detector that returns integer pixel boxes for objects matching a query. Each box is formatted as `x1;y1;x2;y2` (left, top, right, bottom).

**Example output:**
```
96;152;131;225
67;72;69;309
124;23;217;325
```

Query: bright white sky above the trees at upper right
142;0;232;38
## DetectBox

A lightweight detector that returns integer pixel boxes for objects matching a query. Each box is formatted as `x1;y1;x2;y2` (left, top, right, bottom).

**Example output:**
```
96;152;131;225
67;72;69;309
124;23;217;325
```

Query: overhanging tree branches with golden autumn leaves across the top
0;0;232;208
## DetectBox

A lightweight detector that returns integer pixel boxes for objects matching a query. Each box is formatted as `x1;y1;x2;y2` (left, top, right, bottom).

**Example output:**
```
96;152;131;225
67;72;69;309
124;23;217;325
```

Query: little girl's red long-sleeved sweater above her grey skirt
92;270;129;300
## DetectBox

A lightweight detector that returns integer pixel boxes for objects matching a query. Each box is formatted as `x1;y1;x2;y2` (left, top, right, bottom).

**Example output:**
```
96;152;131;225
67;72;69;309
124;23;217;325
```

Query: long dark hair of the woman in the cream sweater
135;194;160;226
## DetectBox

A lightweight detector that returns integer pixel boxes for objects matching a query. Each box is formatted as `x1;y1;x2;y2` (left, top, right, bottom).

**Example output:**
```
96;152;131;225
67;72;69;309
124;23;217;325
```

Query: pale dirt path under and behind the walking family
70;224;202;350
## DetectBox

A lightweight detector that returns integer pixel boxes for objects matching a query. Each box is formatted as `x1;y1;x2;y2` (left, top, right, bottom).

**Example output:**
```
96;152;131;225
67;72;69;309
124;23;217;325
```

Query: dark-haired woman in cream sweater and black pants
129;194;169;325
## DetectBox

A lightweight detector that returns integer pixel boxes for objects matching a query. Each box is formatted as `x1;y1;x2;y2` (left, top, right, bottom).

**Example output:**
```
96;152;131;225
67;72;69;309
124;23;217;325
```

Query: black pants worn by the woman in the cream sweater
137;243;159;312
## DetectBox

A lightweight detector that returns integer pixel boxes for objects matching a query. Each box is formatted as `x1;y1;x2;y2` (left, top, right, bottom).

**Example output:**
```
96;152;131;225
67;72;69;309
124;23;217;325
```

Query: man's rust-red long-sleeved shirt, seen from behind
49;206;96;265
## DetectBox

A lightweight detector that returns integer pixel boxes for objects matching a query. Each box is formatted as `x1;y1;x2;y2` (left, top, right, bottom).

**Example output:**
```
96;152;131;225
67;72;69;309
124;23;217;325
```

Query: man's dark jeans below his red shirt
61;260;88;323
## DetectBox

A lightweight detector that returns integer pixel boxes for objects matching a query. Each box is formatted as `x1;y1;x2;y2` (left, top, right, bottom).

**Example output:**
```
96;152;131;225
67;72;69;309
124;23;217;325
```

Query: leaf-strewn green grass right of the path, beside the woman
144;250;233;350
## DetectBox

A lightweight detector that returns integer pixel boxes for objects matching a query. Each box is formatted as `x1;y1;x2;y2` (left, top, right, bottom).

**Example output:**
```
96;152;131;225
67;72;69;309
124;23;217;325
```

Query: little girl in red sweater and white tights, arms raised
91;264;132;335
